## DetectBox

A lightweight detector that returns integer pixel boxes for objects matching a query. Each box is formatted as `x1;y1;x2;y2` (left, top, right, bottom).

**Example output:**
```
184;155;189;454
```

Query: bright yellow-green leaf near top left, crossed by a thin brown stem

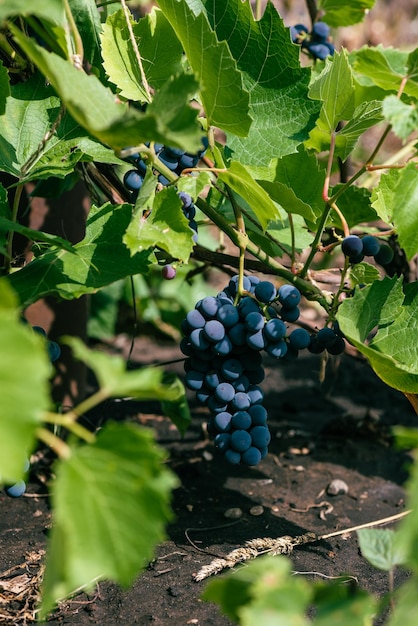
102;9;183;101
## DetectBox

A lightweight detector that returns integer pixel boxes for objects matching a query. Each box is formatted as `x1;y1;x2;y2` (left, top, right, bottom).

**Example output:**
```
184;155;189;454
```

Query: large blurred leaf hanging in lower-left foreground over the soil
41;423;177;619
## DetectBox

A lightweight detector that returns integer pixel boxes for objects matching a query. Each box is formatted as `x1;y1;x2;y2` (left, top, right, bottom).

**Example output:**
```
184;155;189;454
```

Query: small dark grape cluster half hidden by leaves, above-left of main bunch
123;137;208;201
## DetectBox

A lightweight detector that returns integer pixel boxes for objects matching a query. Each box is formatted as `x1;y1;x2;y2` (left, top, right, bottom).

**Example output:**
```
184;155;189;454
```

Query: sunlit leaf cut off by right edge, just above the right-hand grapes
372;163;418;260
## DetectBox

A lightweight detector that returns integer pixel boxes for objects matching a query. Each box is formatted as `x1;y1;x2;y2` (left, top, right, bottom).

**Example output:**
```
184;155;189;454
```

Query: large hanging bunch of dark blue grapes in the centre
180;276;344;466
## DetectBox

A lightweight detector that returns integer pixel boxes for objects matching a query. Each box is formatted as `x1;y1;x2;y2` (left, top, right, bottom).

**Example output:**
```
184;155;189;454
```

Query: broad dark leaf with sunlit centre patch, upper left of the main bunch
0;204;150;307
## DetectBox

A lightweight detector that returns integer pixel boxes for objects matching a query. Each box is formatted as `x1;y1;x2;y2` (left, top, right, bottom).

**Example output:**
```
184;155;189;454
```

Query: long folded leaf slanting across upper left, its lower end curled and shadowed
12;27;201;151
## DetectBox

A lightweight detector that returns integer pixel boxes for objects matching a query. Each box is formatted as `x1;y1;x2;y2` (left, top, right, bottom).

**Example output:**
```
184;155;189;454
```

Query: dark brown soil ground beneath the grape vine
0;336;416;626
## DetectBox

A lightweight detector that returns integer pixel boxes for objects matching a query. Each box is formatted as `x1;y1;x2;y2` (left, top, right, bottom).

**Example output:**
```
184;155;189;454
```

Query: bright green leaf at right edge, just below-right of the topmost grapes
354;45;418;98
